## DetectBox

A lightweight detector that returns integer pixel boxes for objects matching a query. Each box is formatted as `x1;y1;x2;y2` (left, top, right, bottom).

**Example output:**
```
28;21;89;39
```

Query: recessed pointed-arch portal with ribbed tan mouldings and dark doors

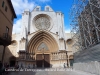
27;31;58;68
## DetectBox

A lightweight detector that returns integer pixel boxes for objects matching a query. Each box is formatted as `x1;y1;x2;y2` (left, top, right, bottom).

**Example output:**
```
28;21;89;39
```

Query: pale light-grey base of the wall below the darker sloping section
73;61;100;75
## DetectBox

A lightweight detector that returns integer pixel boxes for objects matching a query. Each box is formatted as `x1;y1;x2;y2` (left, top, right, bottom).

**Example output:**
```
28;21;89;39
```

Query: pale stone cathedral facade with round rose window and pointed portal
0;6;73;68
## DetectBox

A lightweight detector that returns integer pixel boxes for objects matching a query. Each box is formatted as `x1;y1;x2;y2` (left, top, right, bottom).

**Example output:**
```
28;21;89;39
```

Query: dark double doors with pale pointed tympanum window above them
36;42;50;68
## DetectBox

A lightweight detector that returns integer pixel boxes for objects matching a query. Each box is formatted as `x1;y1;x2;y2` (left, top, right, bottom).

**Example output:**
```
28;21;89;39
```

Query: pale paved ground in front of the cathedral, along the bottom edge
7;69;95;75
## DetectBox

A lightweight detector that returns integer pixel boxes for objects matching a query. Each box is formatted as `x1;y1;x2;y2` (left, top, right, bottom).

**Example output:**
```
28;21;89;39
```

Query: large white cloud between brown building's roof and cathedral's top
11;0;36;15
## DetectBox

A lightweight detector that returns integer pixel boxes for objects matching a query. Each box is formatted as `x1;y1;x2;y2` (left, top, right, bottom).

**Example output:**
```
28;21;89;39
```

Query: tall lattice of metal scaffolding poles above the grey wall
70;0;100;51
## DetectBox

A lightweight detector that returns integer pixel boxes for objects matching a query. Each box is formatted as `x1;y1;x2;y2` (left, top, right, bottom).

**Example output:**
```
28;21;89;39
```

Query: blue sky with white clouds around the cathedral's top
11;0;73;34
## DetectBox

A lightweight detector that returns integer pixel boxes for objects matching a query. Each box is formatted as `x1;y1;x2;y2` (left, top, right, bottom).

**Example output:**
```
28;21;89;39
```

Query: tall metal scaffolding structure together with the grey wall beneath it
70;0;100;74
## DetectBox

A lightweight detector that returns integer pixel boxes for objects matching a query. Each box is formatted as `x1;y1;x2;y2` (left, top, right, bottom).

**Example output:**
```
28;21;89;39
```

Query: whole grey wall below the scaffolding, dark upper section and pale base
73;44;100;75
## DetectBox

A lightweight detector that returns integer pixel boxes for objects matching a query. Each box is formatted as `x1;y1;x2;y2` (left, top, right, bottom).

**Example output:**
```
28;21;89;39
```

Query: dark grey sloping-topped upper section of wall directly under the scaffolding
74;44;100;63
